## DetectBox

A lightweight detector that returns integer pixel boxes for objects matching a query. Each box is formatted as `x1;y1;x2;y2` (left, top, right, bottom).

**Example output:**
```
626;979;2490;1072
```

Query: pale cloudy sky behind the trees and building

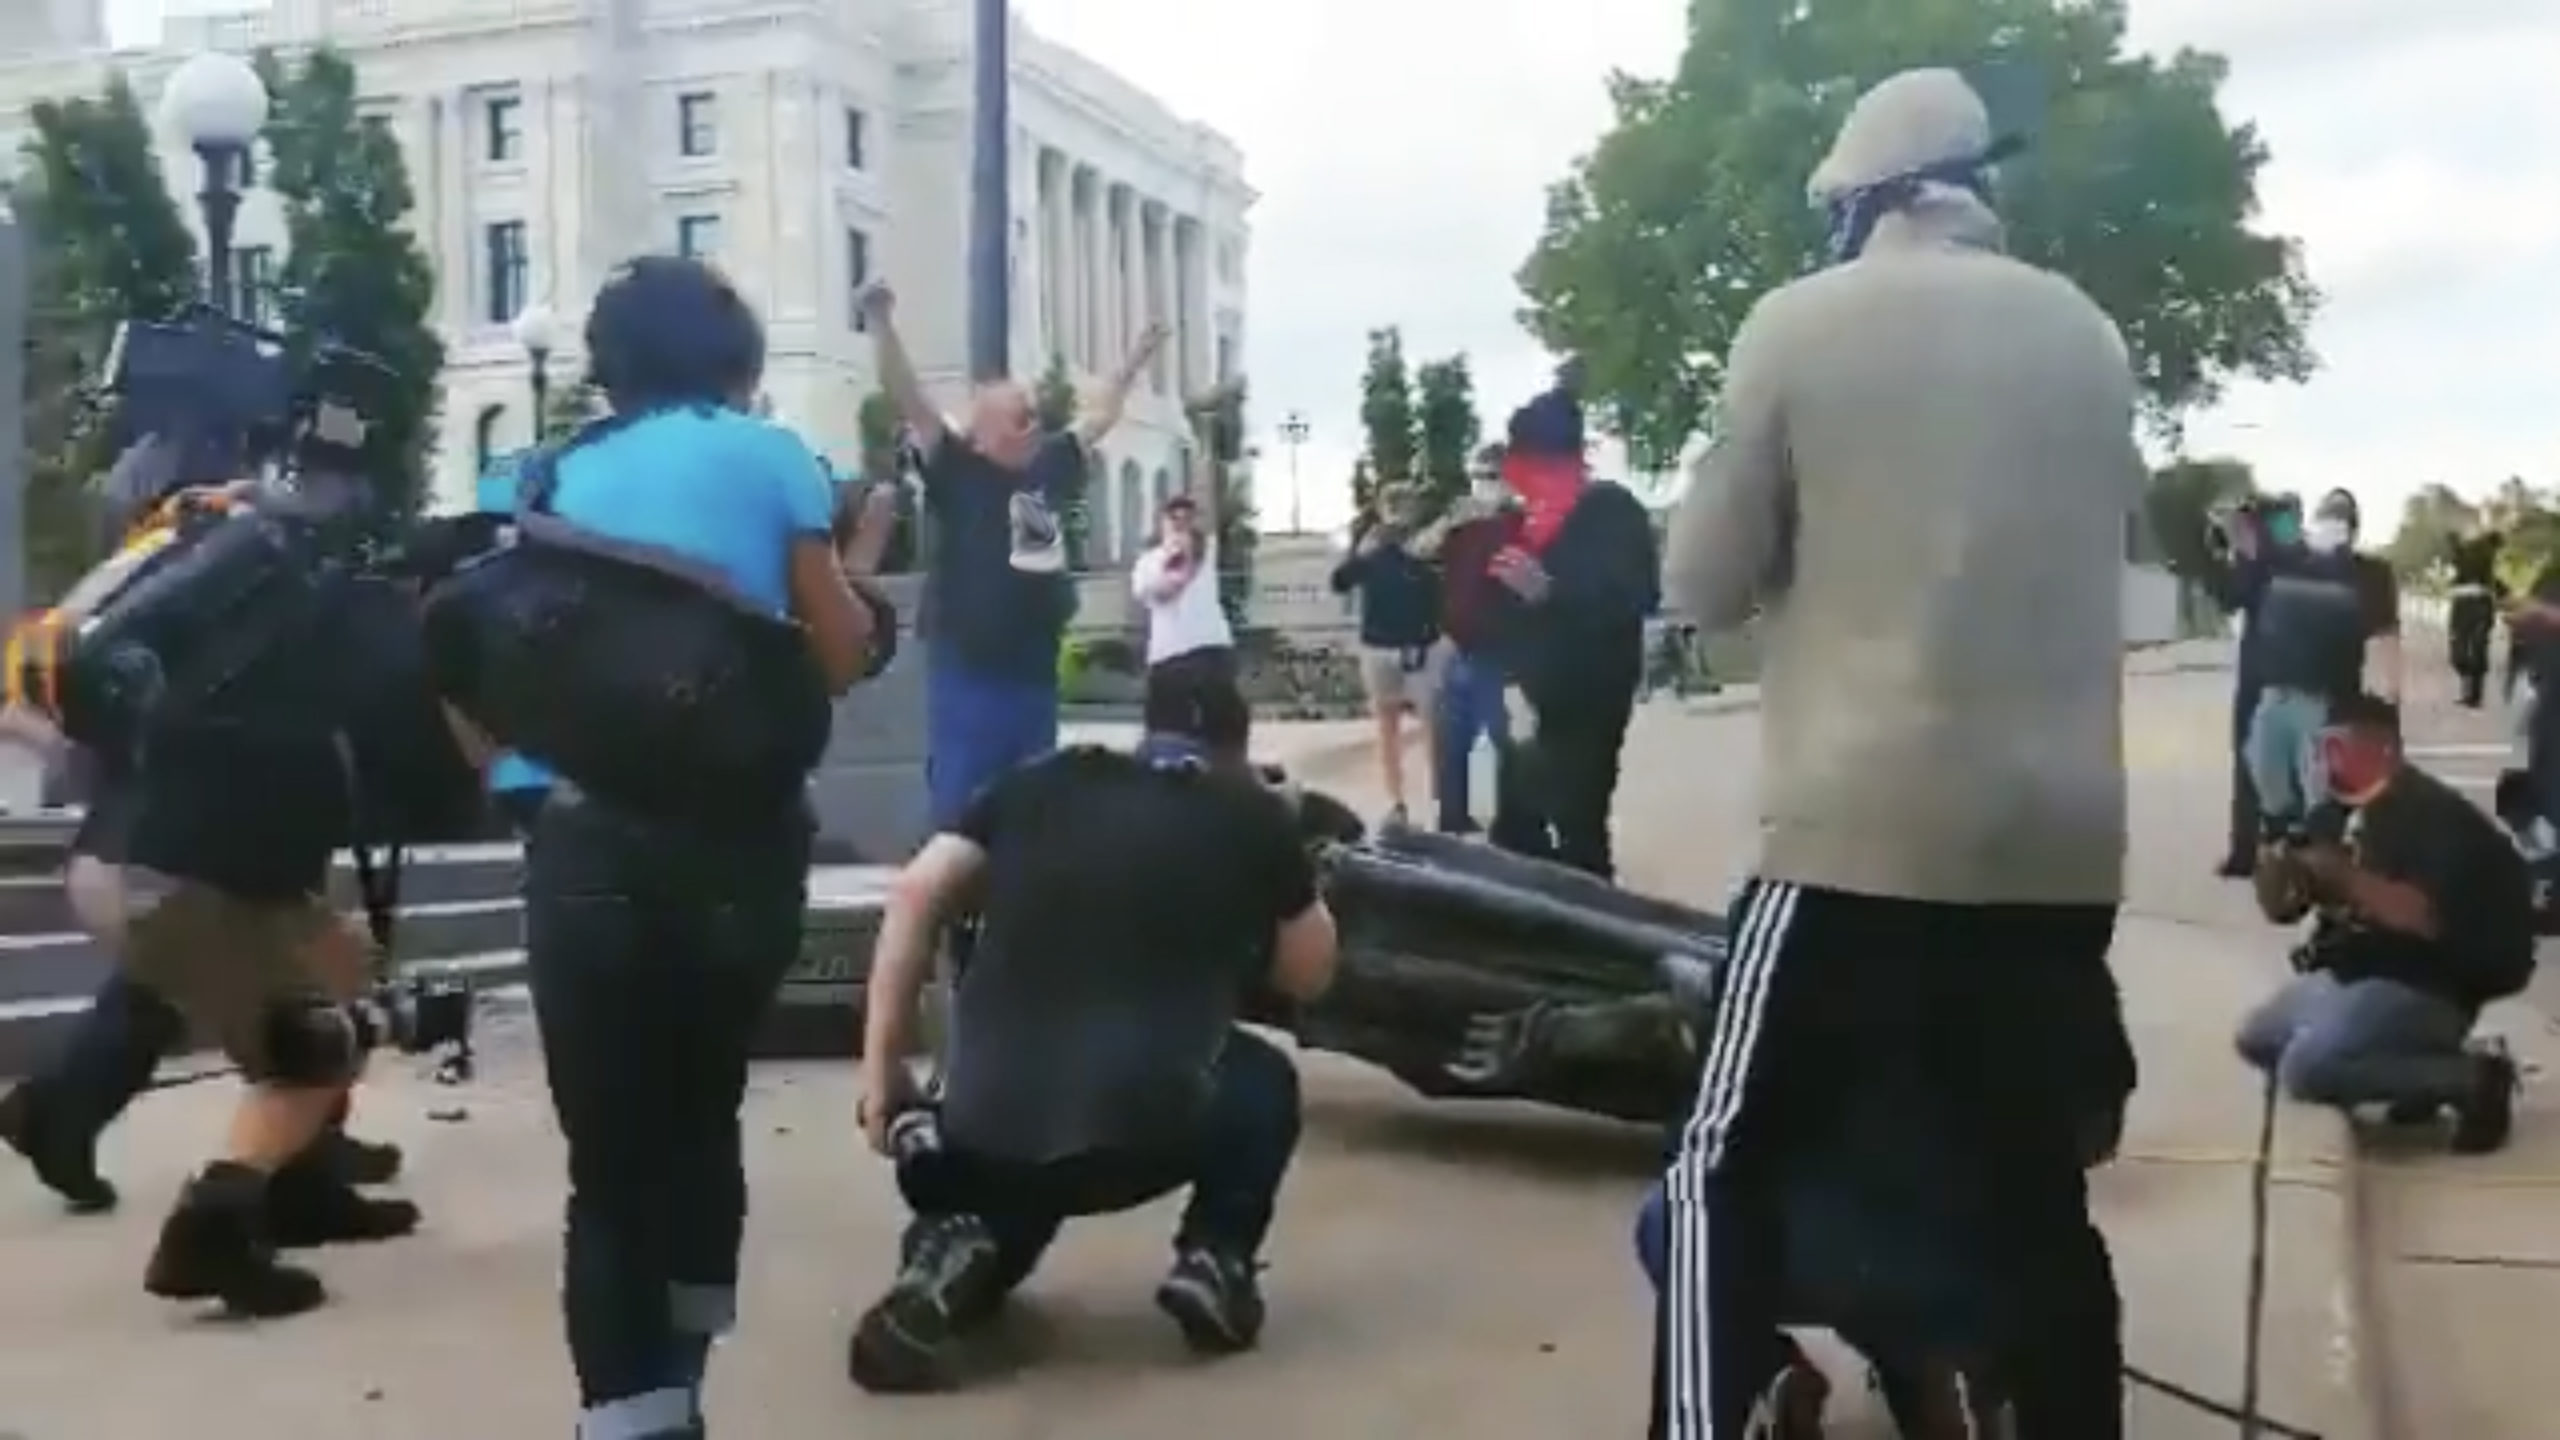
108;0;2560;535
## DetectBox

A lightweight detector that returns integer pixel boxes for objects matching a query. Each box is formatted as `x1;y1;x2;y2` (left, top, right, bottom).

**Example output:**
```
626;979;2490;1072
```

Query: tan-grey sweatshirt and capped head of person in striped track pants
1664;69;2145;904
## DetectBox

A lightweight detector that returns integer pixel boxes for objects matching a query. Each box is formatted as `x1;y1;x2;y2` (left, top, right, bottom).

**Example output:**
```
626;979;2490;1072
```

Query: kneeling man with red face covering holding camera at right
2237;694;2534;1153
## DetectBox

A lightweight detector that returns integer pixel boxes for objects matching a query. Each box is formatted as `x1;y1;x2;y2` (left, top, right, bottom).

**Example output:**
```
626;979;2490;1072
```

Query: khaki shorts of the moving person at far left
123;869;364;1076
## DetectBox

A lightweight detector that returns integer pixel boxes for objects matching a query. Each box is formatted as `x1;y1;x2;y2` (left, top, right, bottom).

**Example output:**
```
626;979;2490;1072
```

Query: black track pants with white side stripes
1651;881;2132;1440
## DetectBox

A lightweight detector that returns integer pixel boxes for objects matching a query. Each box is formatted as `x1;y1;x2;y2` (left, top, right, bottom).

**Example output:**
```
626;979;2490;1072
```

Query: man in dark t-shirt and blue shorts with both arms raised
863;287;1165;830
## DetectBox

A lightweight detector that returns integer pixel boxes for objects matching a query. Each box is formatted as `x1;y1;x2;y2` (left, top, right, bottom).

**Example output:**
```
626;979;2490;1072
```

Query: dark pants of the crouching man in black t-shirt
899;1030;1298;1289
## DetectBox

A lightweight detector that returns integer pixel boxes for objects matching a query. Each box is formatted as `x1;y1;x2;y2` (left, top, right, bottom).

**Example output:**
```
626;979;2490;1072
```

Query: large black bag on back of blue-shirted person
428;441;832;822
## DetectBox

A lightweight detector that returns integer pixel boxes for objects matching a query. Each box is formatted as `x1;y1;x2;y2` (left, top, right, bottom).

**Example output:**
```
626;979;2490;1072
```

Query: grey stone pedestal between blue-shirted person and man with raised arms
812;577;927;866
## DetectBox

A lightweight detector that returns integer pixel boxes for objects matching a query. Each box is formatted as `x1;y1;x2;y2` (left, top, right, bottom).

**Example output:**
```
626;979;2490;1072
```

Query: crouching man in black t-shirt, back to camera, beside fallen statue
847;666;1336;1391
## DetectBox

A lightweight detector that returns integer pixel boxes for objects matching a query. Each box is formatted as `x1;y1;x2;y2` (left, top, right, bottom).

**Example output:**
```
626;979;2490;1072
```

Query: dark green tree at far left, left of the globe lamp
8;74;197;600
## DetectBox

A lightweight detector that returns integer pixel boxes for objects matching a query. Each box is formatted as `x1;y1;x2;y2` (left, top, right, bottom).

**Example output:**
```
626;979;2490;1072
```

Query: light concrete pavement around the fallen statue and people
0;653;2457;1440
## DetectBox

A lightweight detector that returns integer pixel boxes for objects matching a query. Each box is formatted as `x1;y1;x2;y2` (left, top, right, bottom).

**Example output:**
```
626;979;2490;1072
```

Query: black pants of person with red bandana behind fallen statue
1490;684;1636;879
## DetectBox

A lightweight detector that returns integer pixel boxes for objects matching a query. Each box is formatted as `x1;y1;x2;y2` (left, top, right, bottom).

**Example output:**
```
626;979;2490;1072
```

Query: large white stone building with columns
0;0;1254;559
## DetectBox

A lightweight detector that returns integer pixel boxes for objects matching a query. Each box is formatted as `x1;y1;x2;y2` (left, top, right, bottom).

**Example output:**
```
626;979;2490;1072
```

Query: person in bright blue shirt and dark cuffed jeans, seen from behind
504;256;893;1440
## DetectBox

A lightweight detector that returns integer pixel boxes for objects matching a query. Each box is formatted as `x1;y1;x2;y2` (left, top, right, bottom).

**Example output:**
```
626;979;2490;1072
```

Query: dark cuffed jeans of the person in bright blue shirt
525;789;809;1435
